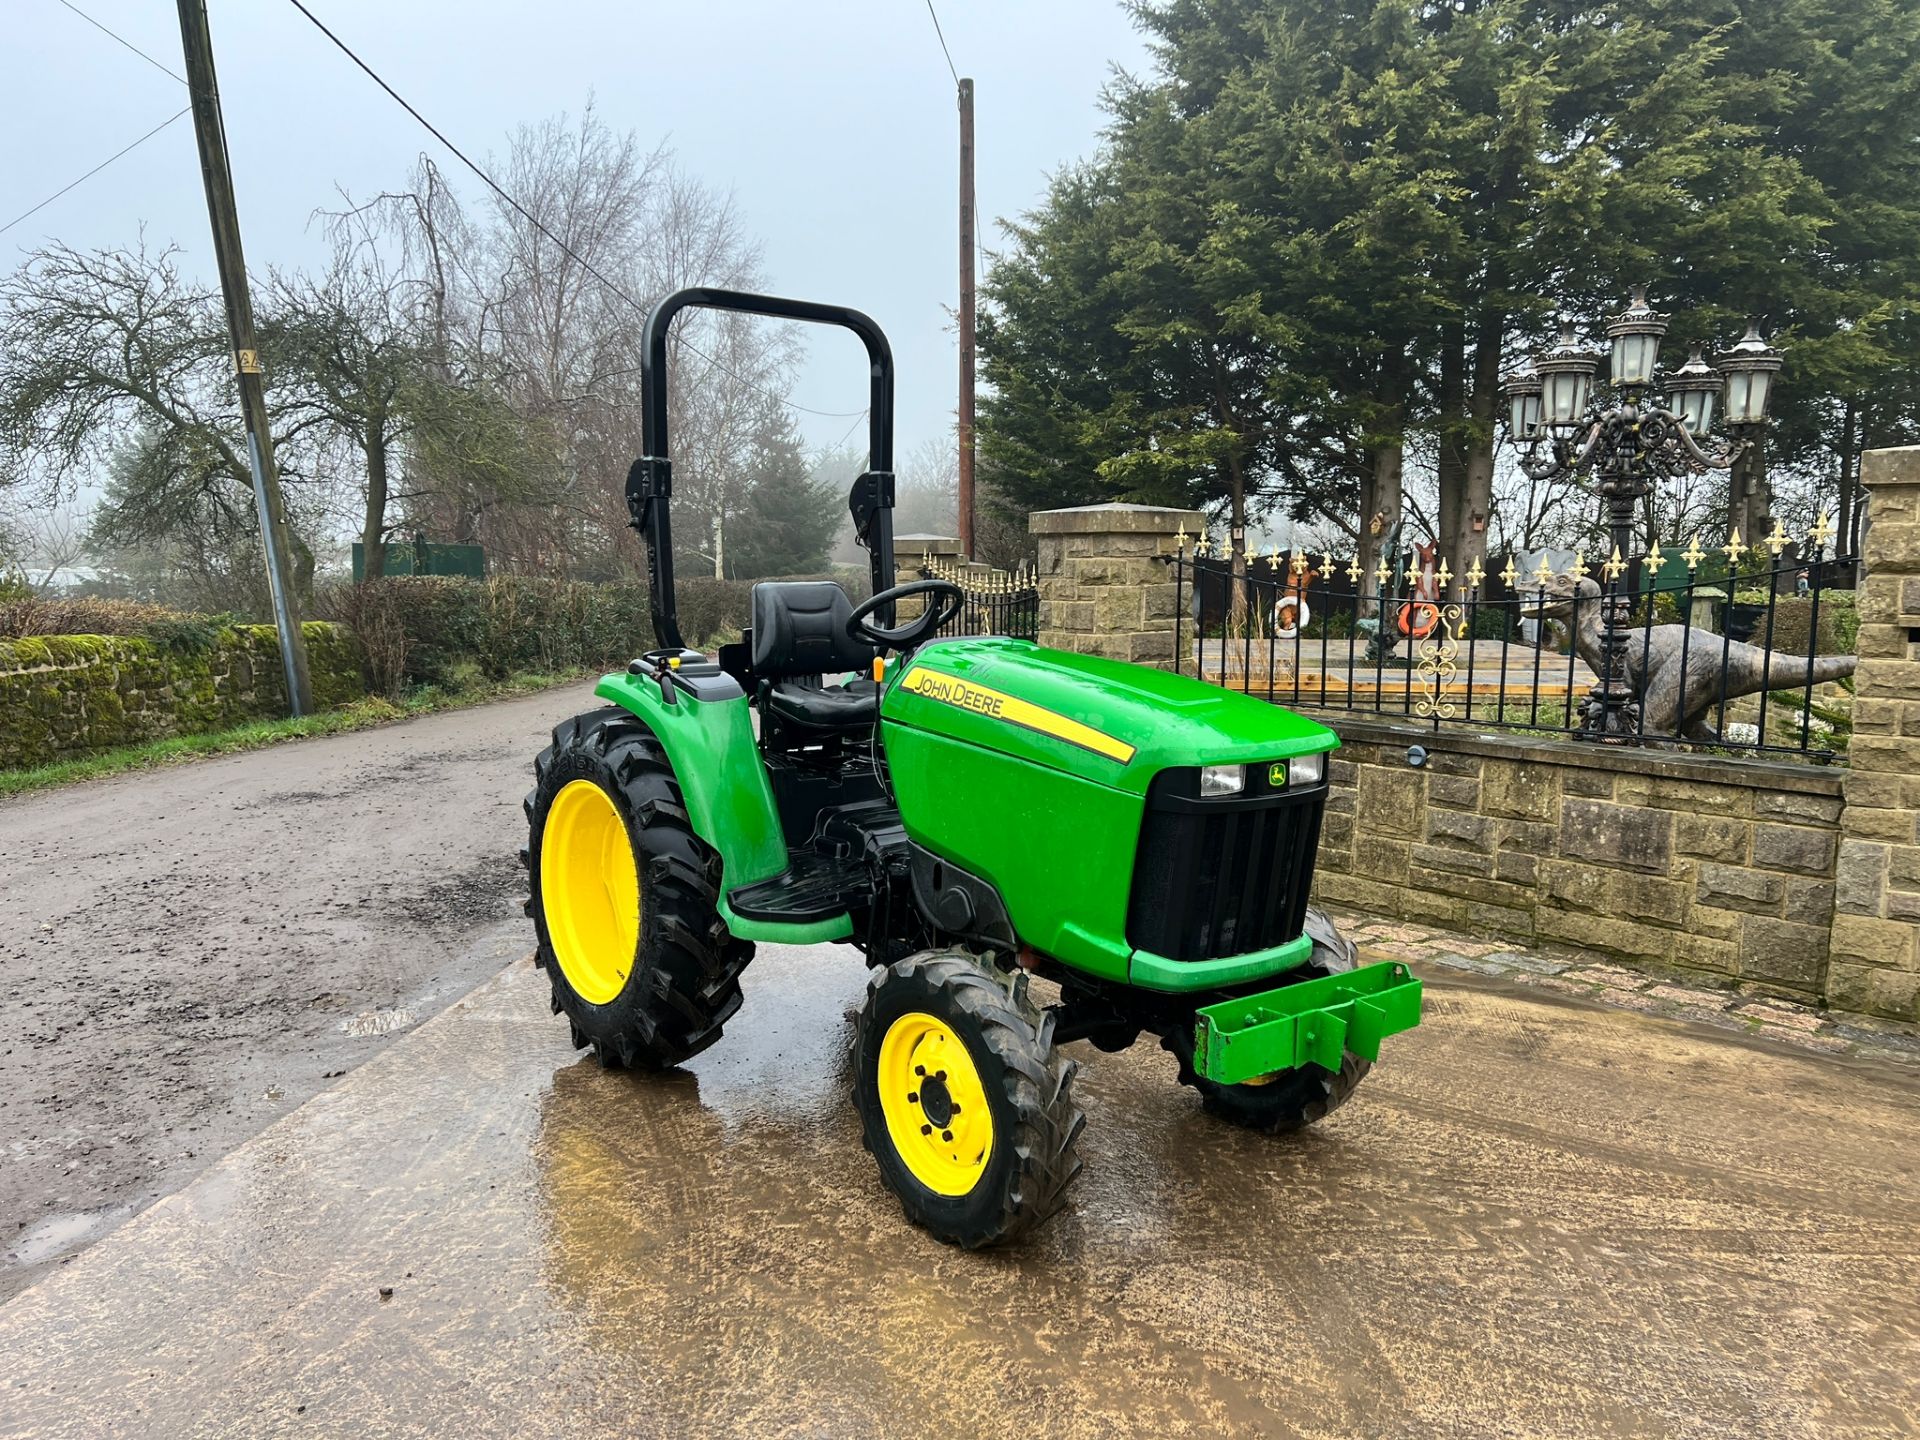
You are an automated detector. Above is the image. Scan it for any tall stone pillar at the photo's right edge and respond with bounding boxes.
[1828,445,1920,1020]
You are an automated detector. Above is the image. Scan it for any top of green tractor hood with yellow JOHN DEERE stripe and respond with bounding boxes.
[881,637,1340,795]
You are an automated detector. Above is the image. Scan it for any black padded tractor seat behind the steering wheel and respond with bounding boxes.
[753,580,879,735]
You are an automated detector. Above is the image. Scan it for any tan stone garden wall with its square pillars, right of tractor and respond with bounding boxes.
[1031,485,1920,1021]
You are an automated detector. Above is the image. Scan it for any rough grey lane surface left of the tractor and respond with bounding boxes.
[0,685,591,1302]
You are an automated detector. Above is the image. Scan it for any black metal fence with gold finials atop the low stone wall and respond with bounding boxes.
[1169,526,1857,762]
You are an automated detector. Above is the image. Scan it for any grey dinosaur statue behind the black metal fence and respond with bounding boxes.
[1521,574,1857,743]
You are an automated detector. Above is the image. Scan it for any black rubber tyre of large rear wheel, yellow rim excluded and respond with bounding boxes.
[520,707,753,1069]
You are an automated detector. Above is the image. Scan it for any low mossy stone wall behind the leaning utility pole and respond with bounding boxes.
[0,622,367,770]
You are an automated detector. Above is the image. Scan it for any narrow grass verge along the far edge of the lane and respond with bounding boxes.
[0,672,597,797]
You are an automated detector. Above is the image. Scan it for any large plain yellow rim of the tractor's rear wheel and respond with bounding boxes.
[540,780,639,1004]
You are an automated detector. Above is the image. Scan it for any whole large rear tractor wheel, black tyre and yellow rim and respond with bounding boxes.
[520,708,753,1069]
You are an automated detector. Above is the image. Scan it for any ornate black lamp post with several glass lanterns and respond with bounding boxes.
[1505,288,1780,743]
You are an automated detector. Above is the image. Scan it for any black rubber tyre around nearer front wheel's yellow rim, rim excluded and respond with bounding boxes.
[852,950,1087,1250]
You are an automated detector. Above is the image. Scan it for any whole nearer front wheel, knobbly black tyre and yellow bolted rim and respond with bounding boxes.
[852,950,1085,1250]
